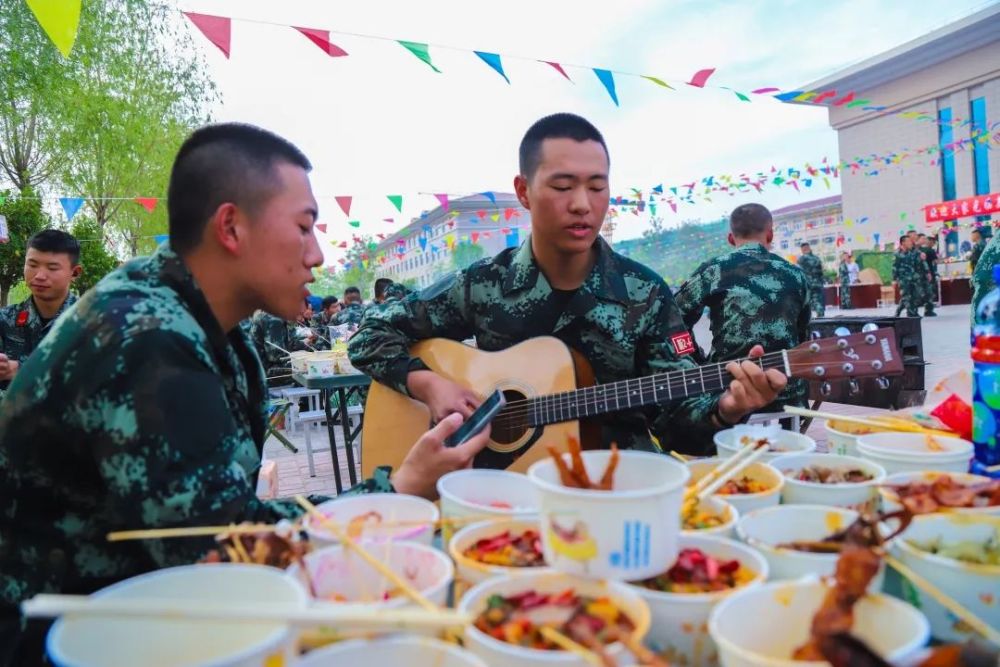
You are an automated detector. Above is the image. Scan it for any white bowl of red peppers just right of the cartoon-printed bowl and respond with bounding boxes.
[632,535,768,666]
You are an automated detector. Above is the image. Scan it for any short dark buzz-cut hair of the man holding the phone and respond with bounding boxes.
[167,123,312,255]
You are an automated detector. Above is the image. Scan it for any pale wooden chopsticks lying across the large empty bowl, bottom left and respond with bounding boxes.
[21,594,472,630]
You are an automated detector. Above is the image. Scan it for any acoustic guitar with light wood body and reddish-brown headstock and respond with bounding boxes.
[361,329,903,477]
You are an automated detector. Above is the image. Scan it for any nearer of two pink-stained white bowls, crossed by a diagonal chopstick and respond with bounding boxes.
[286,542,455,608]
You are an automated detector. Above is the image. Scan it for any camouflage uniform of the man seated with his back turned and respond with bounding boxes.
[674,243,810,412]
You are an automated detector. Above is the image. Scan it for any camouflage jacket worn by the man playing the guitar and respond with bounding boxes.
[348,239,719,454]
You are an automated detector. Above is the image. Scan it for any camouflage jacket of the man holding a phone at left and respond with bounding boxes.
[0,245,391,614]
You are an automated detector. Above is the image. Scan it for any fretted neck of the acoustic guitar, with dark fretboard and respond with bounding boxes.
[519,352,788,426]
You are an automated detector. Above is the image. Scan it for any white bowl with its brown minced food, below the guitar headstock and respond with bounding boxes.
[773,454,885,512]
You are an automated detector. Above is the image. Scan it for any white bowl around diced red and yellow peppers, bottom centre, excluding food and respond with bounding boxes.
[458,568,661,667]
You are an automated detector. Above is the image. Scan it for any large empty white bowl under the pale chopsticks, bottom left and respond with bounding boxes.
[46,563,308,667]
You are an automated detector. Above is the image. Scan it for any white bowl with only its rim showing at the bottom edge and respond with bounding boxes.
[293,637,487,667]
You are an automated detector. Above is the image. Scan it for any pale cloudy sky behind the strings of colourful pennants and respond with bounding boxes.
[178,0,989,263]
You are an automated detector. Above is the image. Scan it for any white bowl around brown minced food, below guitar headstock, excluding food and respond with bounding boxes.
[774,454,885,512]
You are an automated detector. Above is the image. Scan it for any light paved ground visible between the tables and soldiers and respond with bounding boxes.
[264,305,971,497]
